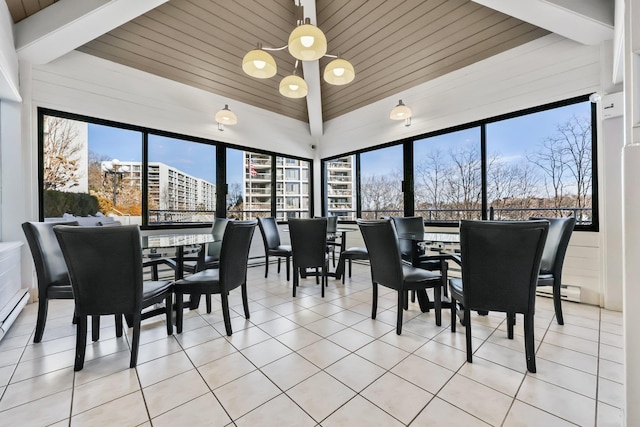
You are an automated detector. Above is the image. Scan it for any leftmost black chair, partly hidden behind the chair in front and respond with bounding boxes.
[22,221,78,343]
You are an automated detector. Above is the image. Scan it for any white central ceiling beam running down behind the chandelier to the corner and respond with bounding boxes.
[294,0,323,138]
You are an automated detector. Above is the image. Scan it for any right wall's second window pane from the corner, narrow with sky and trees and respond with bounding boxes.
[360,145,404,219]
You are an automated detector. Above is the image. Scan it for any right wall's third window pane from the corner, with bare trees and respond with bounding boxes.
[413,128,482,222]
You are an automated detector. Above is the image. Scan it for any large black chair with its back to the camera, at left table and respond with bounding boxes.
[53,225,173,371]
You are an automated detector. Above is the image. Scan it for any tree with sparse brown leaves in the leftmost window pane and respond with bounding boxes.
[43,116,83,190]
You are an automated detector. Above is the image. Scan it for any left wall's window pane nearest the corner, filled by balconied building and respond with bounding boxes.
[276,157,309,220]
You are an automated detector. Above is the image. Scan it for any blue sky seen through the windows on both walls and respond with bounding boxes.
[89,102,590,183]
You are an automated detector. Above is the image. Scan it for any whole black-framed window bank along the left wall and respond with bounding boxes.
[38,108,312,228]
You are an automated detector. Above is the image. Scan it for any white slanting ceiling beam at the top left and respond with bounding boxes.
[14,0,168,64]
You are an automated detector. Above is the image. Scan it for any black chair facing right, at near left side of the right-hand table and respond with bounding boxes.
[357,219,442,335]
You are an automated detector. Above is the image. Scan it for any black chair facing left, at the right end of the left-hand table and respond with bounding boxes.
[174,220,257,336]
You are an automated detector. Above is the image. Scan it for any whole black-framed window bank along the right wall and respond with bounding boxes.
[323,95,598,231]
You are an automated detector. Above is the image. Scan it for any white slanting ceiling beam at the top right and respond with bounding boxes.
[473,0,614,45]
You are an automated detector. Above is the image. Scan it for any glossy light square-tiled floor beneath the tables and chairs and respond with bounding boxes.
[0,265,623,427]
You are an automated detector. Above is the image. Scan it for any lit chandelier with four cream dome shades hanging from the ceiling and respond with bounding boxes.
[242,3,356,98]
